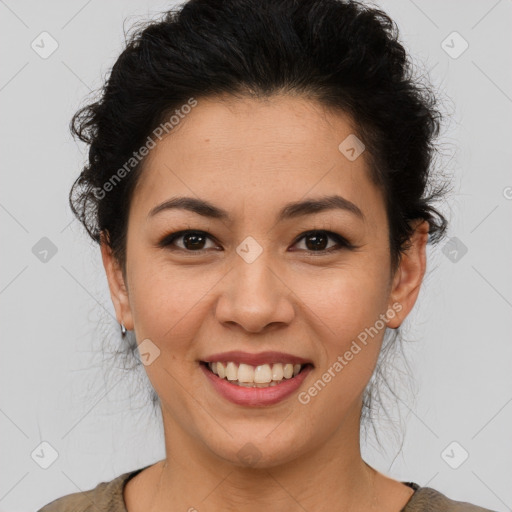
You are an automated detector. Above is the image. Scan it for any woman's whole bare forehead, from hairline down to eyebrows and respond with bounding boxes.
[132,96,380,223]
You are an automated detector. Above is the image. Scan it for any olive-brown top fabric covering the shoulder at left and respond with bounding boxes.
[37,466,147,512]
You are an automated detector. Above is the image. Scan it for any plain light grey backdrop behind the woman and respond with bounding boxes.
[0,0,512,512]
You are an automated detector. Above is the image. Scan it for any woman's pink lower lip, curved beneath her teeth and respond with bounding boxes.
[200,364,313,406]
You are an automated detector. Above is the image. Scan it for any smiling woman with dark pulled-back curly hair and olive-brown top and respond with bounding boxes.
[41,0,494,512]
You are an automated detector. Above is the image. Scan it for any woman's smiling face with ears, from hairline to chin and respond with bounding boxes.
[102,96,426,466]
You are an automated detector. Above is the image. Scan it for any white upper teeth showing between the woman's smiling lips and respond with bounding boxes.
[200,361,313,388]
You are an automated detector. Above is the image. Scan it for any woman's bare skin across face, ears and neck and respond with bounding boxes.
[101,95,428,512]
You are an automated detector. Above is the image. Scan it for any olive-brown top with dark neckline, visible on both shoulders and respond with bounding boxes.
[37,466,495,512]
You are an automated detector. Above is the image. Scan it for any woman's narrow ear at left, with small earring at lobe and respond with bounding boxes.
[100,231,133,331]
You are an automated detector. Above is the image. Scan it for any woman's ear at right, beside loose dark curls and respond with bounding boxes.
[388,220,429,329]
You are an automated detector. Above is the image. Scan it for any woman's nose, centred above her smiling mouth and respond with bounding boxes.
[215,246,295,333]
